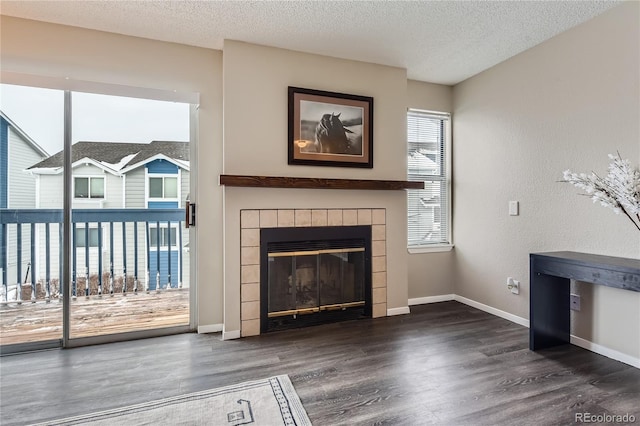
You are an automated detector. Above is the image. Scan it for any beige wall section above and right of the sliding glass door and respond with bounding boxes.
[0,16,222,324]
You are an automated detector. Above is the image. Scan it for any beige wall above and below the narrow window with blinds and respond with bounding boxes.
[407,80,456,299]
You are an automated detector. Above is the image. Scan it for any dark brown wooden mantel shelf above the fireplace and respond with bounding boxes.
[220,175,424,191]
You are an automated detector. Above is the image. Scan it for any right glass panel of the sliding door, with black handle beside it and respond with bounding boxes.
[69,92,191,338]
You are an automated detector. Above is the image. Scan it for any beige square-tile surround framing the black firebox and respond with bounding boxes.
[240,208,387,337]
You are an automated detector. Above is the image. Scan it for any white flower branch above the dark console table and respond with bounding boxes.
[563,153,640,231]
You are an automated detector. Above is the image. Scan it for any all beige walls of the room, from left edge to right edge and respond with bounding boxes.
[1,3,640,358]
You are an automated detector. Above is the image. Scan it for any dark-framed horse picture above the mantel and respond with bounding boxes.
[289,87,373,169]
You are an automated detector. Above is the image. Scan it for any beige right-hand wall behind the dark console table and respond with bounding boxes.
[453,2,640,359]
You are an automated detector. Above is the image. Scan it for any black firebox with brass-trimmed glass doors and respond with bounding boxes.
[260,226,371,333]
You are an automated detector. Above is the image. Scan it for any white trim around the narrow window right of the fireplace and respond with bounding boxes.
[405,108,455,254]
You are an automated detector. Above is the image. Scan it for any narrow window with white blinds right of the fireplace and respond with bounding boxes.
[407,109,451,248]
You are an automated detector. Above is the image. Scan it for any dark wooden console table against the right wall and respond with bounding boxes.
[529,251,640,351]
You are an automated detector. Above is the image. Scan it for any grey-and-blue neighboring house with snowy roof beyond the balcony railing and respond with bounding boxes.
[28,141,189,289]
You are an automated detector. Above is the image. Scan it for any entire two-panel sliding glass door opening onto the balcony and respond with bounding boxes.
[0,80,196,352]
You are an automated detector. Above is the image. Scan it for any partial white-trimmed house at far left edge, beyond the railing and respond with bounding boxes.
[0,111,49,292]
